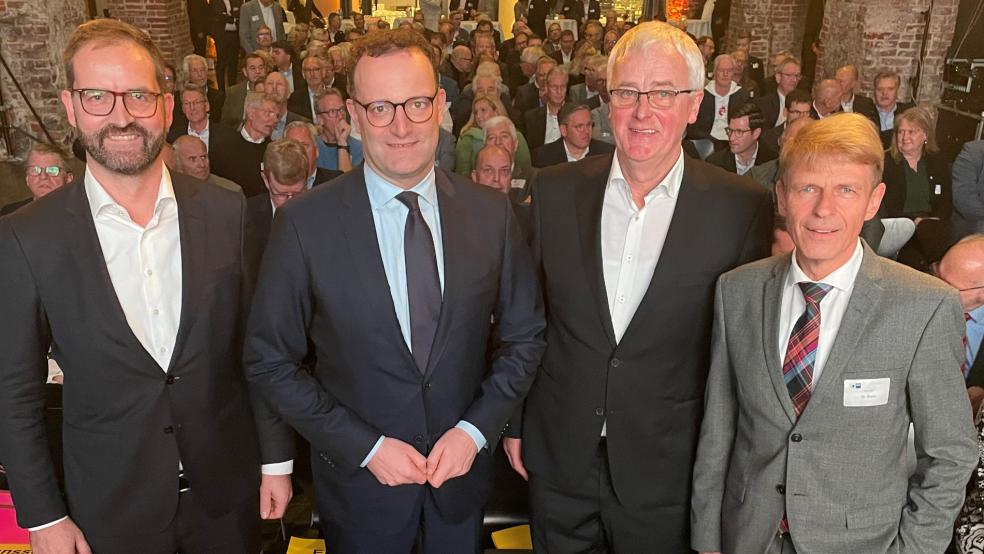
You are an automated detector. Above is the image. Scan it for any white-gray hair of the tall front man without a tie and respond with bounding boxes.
[608,21,704,90]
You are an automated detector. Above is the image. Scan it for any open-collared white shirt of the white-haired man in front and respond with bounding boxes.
[601,150,683,437]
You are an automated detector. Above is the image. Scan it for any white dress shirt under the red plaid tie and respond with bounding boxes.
[776,240,864,382]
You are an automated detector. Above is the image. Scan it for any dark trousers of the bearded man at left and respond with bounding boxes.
[83,487,260,554]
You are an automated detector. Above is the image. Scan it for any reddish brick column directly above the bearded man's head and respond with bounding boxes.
[106,0,194,65]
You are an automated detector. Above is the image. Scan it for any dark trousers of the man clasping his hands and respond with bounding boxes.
[322,485,482,554]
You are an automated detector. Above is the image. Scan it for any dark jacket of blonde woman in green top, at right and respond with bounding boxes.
[880,153,953,220]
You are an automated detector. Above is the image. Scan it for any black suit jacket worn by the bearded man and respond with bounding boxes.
[0,173,293,536]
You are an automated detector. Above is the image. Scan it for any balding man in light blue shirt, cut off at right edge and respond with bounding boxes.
[938,234,984,414]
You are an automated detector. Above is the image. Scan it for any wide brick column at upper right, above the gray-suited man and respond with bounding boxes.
[817,0,959,102]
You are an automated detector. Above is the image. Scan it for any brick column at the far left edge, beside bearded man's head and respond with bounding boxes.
[0,0,86,160]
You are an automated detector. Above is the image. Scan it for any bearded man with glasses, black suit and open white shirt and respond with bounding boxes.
[0,19,293,553]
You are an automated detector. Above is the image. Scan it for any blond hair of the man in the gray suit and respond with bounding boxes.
[779,113,885,187]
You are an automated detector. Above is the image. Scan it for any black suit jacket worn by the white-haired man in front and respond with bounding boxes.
[507,156,772,552]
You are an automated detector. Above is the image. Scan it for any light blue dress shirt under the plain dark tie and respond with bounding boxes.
[362,164,486,467]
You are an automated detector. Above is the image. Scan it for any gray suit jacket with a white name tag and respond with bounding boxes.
[691,246,977,553]
